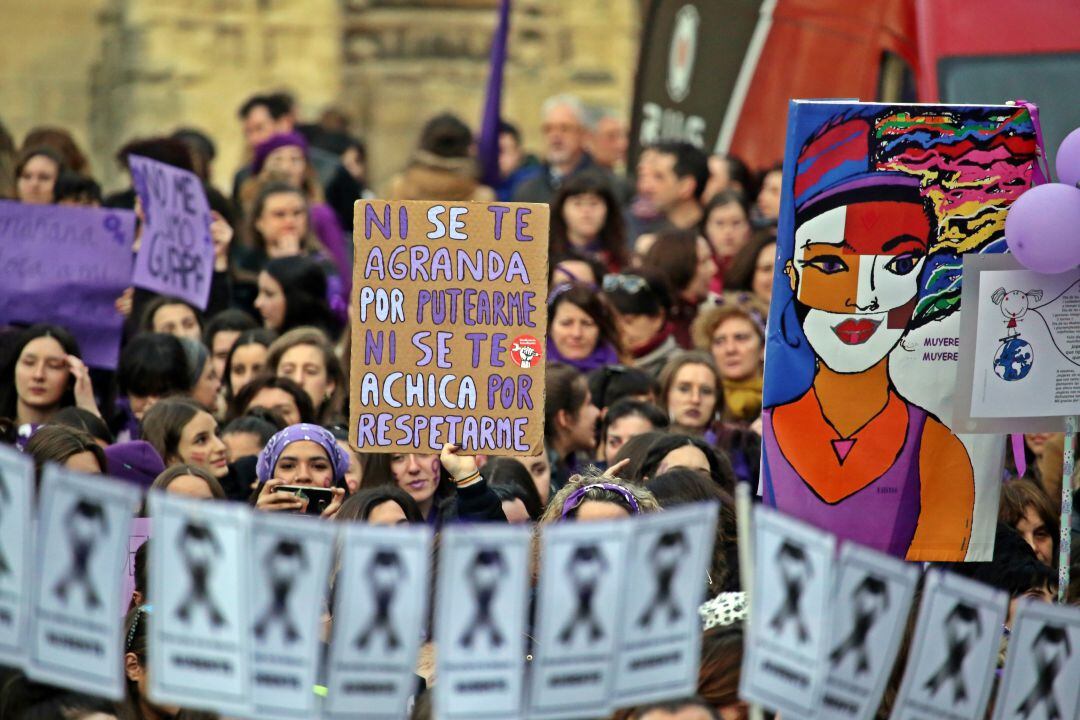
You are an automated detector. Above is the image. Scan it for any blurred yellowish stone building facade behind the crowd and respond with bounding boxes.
[0,0,639,189]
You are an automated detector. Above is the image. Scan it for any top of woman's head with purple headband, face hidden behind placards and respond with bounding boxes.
[540,475,660,525]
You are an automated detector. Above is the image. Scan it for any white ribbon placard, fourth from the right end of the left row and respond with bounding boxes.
[324,524,432,720]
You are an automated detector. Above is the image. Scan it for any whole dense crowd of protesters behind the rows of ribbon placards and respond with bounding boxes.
[0,88,1077,720]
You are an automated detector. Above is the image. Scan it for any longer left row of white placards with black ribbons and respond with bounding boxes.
[0,449,717,719]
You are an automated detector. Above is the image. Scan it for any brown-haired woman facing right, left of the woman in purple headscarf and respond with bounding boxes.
[143,397,229,481]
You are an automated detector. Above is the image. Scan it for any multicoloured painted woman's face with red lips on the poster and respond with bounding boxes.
[786,202,931,372]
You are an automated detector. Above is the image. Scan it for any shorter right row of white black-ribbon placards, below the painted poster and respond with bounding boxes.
[740,506,1080,720]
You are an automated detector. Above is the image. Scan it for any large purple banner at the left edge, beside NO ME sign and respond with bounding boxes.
[0,200,135,370]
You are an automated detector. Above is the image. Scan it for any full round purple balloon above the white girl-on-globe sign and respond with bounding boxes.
[1005,182,1080,274]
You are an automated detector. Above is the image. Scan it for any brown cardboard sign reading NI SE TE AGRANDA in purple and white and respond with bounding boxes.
[350,201,548,456]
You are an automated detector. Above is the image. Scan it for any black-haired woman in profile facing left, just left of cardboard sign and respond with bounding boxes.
[255,256,341,340]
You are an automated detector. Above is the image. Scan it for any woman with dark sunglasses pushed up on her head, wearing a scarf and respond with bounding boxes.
[604,268,679,377]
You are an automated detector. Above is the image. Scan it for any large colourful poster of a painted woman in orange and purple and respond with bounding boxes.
[761,100,1036,560]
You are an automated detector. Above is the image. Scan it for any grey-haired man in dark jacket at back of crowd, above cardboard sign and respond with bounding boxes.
[514,95,596,203]
